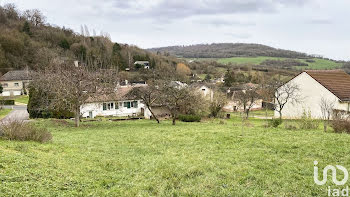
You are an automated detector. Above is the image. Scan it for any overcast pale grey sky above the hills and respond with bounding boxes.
[0,0,350,60]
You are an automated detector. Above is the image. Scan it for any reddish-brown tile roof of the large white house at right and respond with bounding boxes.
[305,70,350,101]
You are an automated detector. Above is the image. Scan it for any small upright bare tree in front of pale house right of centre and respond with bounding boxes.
[234,87,260,119]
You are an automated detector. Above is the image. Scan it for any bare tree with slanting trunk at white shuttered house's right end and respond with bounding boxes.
[130,84,160,124]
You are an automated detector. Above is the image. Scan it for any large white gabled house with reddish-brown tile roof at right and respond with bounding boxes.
[275,70,350,119]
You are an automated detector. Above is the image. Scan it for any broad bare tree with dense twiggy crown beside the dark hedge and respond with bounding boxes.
[32,64,117,127]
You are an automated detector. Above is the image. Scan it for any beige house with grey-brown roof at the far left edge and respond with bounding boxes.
[0,70,32,96]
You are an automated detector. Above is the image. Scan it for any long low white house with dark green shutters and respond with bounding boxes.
[80,85,150,118]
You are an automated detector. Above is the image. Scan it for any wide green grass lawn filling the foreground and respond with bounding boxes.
[0,118,350,196]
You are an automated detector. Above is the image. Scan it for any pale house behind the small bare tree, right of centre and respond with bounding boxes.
[223,83,263,112]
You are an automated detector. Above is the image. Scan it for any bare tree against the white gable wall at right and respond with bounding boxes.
[270,81,302,120]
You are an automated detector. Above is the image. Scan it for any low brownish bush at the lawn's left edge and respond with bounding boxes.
[0,121,52,143]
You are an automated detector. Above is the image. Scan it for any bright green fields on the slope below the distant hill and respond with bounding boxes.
[217,57,341,69]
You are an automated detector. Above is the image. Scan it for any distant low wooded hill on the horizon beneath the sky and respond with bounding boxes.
[148,43,309,58]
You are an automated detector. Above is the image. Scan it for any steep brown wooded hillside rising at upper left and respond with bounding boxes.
[0,4,176,73]
